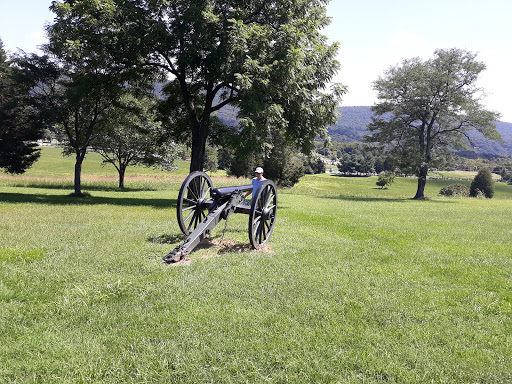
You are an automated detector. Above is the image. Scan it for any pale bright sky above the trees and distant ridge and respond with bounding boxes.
[0,0,512,122]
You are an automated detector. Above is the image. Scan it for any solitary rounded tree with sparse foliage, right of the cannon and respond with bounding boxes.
[366,48,500,199]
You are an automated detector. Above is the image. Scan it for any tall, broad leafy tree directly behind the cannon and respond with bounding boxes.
[51,0,344,171]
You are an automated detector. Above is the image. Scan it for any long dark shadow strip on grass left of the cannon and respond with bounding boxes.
[0,192,177,208]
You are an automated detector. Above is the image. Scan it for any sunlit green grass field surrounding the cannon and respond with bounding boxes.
[0,148,512,383]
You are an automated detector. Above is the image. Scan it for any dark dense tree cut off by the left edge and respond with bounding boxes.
[0,39,42,173]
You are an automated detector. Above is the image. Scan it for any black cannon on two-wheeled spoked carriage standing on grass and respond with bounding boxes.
[163,171,277,264]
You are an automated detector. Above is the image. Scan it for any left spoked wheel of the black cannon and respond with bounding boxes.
[177,171,213,236]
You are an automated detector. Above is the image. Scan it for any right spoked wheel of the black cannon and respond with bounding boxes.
[249,180,277,249]
